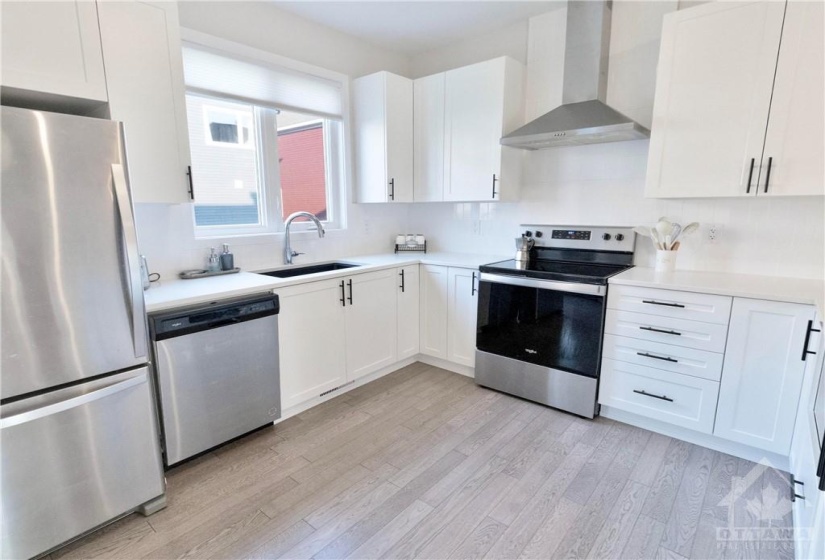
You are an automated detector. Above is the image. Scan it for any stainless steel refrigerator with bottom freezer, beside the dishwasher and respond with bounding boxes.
[0,107,165,558]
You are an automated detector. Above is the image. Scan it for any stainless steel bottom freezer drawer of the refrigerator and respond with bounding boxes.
[0,367,165,558]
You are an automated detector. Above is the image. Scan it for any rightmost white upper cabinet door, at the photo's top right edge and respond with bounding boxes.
[759,0,825,196]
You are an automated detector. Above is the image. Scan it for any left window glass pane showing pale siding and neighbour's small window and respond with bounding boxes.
[186,95,261,227]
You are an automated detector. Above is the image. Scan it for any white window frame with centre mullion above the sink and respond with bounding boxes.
[181,28,352,240]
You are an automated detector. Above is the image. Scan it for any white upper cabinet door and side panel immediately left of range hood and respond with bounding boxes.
[444,57,524,201]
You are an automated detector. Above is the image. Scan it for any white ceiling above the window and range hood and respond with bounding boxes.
[274,0,563,55]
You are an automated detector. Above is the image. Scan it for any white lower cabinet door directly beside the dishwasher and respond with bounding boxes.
[278,280,347,411]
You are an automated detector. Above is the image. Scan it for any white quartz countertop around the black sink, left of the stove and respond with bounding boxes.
[144,253,509,313]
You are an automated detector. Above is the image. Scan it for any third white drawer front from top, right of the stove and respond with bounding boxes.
[602,334,724,381]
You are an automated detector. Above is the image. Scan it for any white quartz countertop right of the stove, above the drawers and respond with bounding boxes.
[610,267,825,317]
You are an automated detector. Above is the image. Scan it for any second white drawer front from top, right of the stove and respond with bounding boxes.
[604,309,728,353]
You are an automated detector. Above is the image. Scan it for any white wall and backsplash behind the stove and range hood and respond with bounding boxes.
[408,0,825,278]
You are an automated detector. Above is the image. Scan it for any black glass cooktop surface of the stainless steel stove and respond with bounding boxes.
[479,259,631,284]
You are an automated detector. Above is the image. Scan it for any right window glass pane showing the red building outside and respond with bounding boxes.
[278,111,330,221]
